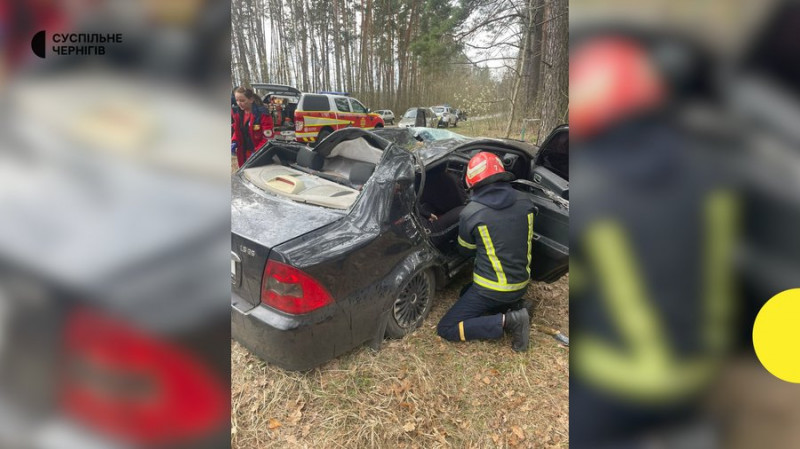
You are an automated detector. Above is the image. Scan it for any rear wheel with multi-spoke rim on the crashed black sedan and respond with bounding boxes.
[386,270,436,338]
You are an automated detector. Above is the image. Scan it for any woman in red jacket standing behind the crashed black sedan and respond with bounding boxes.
[231,87,273,167]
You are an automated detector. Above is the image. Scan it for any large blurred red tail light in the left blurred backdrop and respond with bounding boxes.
[60,309,230,445]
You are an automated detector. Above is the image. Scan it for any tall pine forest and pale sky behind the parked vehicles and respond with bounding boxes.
[231,0,569,141]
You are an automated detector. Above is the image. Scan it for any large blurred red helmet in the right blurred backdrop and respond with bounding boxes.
[569,36,666,138]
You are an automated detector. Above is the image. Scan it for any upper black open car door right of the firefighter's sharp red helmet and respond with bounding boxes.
[531,125,569,199]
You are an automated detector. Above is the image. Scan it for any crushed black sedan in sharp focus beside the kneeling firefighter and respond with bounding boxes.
[231,128,569,370]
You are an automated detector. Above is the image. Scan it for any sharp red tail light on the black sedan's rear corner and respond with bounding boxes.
[261,260,333,315]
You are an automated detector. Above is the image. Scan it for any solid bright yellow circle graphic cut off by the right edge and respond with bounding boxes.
[753,288,800,383]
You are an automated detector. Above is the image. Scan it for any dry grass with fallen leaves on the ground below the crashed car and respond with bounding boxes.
[231,274,569,448]
